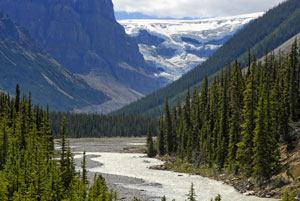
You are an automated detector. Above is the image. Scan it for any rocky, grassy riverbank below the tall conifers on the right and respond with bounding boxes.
[151,130,300,200]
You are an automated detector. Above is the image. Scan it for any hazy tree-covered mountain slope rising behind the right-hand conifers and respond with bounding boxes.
[117,0,300,115]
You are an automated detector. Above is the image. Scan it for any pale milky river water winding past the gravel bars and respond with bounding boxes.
[75,152,275,201]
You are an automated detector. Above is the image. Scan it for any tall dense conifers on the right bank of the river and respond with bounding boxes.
[148,41,300,182]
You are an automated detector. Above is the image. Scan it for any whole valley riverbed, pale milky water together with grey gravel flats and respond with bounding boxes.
[62,138,278,201]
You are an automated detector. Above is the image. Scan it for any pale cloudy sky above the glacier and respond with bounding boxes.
[113,0,283,18]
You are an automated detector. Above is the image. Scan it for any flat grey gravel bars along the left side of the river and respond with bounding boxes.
[66,138,153,201]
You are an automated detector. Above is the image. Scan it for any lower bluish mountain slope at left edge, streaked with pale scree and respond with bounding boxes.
[0,11,109,111]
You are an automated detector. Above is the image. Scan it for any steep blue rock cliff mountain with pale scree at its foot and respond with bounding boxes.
[0,0,163,112]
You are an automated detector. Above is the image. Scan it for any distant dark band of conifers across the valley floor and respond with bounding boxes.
[50,112,158,138]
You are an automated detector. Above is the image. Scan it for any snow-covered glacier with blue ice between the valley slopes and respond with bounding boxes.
[119,13,263,82]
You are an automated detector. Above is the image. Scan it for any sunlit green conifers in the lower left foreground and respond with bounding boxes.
[0,86,116,201]
